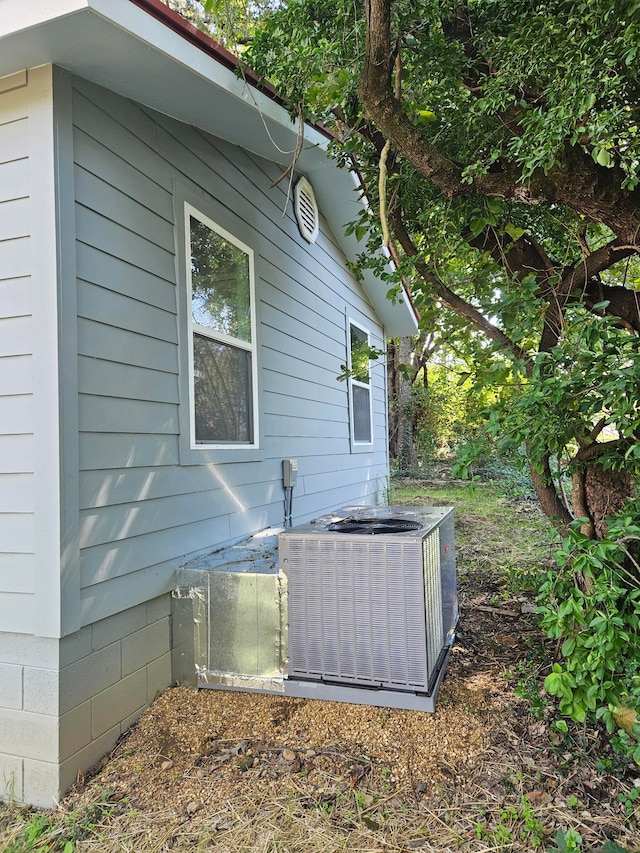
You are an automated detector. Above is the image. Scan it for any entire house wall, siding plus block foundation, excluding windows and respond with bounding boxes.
[0,66,388,806]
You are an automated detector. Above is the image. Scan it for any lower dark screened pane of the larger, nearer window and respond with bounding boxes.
[193,335,253,444]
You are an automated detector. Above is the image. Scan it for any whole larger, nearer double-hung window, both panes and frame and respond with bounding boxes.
[185,205,257,448]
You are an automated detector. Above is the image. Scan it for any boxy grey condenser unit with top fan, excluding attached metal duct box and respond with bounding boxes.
[278,506,458,711]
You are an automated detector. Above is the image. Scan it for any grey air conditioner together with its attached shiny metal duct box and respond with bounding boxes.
[172,506,458,712]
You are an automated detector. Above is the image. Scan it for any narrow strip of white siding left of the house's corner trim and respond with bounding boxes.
[0,75,35,612]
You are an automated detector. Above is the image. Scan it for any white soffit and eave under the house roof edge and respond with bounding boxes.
[0,0,417,335]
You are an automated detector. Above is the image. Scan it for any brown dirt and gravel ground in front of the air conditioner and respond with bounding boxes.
[60,500,640,853]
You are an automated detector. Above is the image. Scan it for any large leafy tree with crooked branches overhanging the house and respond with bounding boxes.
[242,0,640,536]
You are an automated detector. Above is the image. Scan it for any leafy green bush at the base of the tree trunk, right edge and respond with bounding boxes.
[537,502,640,732]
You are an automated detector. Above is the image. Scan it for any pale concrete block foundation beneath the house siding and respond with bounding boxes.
[0,595,171,808]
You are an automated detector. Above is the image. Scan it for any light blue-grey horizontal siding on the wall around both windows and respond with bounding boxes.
[73,80,386,622]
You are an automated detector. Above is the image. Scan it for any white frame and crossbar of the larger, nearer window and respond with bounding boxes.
[184,202,260,453]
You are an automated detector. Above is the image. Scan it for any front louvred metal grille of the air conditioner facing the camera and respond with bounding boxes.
[288,532,432,690]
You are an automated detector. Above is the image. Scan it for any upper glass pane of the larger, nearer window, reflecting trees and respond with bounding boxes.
[190,216,251,342]
